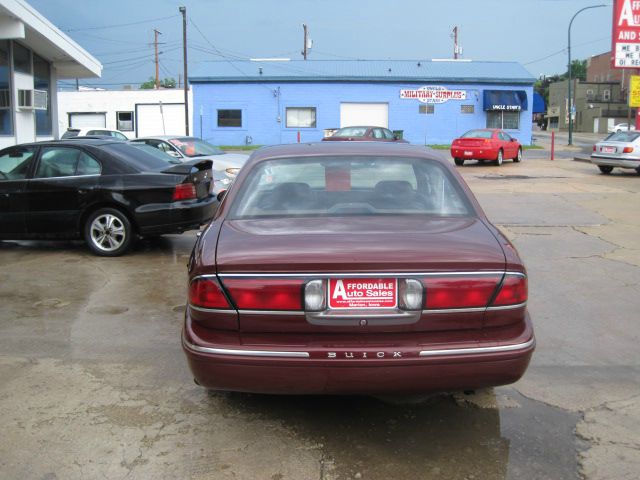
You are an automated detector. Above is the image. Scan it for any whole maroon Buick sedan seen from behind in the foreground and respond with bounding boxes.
[182,142,535,394]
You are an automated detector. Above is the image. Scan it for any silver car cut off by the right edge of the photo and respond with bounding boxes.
[591,130,640,175]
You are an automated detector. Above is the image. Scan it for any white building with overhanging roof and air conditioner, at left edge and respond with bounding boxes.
[0,0,102,148]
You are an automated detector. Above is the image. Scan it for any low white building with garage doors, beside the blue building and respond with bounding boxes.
[58,88,191,138]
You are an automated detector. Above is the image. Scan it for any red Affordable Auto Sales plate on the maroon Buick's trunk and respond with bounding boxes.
[328,278,398,309]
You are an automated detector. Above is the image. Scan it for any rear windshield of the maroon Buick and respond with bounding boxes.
[229,156,473,219]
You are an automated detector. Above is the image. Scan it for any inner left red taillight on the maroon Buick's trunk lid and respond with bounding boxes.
[224,278,304,310]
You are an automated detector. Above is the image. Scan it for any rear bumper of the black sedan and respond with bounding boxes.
[135,195,218,235]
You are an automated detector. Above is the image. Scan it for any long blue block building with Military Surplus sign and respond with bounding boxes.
[189,59,535,145]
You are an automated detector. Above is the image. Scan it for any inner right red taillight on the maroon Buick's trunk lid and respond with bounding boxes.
[423,275,500,310]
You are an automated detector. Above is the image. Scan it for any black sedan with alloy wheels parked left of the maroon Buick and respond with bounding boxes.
[0,139,218,256]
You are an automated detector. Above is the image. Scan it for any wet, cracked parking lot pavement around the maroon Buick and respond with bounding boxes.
[0,150,640,480]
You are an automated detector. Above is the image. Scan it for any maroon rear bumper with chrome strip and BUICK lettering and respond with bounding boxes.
[182,315,535,394]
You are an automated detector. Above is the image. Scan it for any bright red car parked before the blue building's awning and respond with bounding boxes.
[451,128,522,167]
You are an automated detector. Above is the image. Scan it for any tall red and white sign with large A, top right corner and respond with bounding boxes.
[611,0,640,68]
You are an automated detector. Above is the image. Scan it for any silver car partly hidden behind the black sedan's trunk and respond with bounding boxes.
[132,135,249,182]
